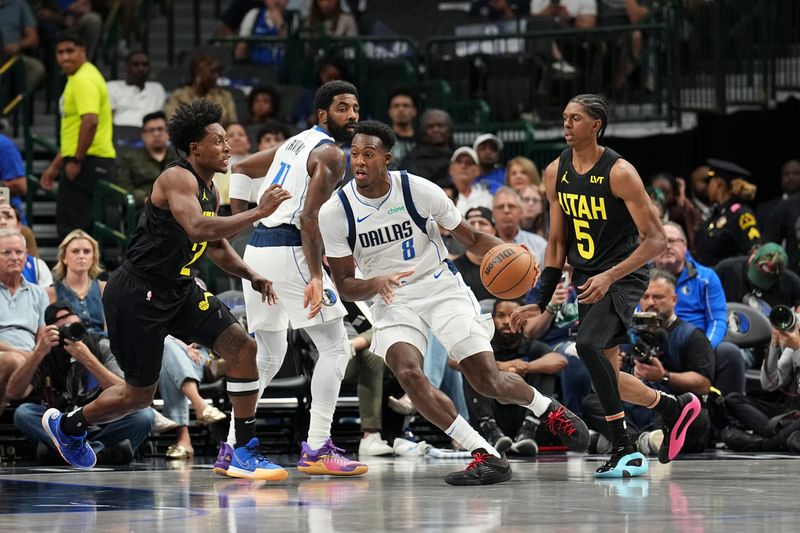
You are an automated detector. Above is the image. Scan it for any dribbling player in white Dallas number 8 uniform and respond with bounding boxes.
[319,121,589,485]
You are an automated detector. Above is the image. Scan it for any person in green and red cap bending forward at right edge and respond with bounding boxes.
[714,242,800,314]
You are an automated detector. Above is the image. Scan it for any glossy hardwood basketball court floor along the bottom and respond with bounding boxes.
[0,453,800,533]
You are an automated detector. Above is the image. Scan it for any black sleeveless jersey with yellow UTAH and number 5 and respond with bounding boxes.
[556,148,639,273]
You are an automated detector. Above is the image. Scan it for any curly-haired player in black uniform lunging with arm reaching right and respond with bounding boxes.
[42,100,290,479]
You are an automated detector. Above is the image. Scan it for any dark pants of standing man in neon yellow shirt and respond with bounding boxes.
[56,156,114,240]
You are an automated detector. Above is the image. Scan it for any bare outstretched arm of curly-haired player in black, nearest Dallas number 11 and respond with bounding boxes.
[156,167,291,242]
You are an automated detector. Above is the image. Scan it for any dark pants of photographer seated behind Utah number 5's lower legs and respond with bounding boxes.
[583,393,711,453]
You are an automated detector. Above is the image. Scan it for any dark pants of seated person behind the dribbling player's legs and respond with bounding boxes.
[463,374,556,437]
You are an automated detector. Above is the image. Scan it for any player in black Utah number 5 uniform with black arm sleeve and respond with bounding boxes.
[511,94,700,477]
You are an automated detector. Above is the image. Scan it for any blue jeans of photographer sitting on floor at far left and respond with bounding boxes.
[14,403,154,453]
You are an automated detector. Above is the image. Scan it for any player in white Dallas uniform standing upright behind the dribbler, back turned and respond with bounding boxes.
[214,81,367,476]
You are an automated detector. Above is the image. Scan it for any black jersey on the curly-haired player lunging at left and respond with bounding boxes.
[125,160,217,281]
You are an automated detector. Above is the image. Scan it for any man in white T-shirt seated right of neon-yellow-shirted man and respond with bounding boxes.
[106,51,167,128]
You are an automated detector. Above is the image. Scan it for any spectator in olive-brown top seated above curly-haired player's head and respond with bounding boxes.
[164,54,239,126]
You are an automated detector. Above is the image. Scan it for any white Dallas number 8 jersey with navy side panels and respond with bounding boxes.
[320,171,461,281]
